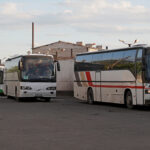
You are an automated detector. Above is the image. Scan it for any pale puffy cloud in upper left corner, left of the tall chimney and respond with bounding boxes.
[0,2,34,30]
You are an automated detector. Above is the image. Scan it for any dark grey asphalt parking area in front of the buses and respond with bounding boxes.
[0,96,150,150]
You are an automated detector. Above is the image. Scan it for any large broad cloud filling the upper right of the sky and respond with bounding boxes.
[52,0,150,33]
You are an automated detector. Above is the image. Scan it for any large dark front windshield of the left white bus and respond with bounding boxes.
[21,56,55,82]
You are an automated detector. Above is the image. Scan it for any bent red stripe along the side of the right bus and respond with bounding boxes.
[86,72,144,89]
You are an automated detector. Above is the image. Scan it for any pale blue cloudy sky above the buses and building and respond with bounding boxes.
[0,0,150,59]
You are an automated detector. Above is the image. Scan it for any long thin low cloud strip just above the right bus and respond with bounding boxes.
[74,23,150,36]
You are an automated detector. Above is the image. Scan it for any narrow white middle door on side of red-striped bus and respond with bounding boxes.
[94,71,101,101]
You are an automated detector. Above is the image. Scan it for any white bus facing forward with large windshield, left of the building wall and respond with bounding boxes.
[4,54,59,101]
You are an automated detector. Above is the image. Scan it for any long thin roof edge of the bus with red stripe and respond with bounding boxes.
[77,44,150,56]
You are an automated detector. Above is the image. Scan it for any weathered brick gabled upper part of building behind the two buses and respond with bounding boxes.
[32,41,97,59]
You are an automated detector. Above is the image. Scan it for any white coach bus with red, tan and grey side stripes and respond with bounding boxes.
[74,45,150,108]
